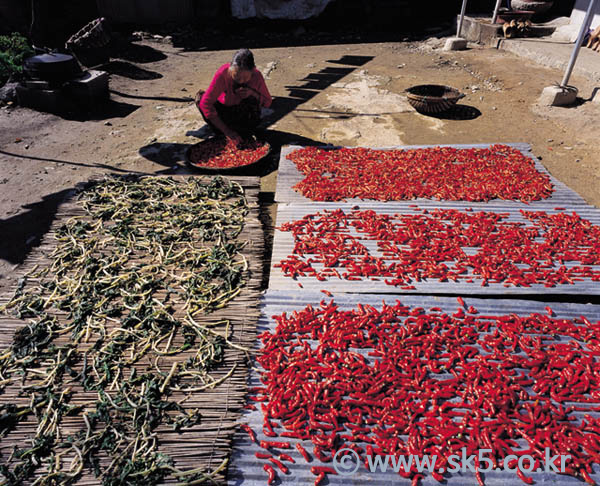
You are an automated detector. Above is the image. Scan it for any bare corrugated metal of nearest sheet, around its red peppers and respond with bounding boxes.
[228,291,600,486]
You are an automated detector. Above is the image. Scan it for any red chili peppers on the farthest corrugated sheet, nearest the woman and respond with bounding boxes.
[288,145,552,201]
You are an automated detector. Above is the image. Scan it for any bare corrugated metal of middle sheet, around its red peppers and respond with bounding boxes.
[269,201,600,295]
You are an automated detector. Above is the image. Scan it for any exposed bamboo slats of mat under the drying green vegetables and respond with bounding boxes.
[0,176,264,486]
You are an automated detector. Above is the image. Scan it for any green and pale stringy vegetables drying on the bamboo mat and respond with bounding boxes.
[0,177,248,486]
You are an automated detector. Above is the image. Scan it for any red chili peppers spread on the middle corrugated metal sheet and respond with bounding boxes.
[276,208,600,290]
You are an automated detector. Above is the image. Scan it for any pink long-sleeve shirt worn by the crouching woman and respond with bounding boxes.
[198,63,273,118]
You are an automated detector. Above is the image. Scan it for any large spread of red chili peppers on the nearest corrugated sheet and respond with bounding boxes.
[244,297,600,485]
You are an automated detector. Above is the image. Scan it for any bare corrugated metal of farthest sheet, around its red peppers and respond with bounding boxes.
[275,143,586,209]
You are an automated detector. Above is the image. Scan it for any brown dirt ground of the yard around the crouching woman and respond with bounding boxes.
[0,38,600,291]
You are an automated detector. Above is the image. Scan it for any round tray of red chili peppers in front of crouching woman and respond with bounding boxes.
[186,138,271,172]
